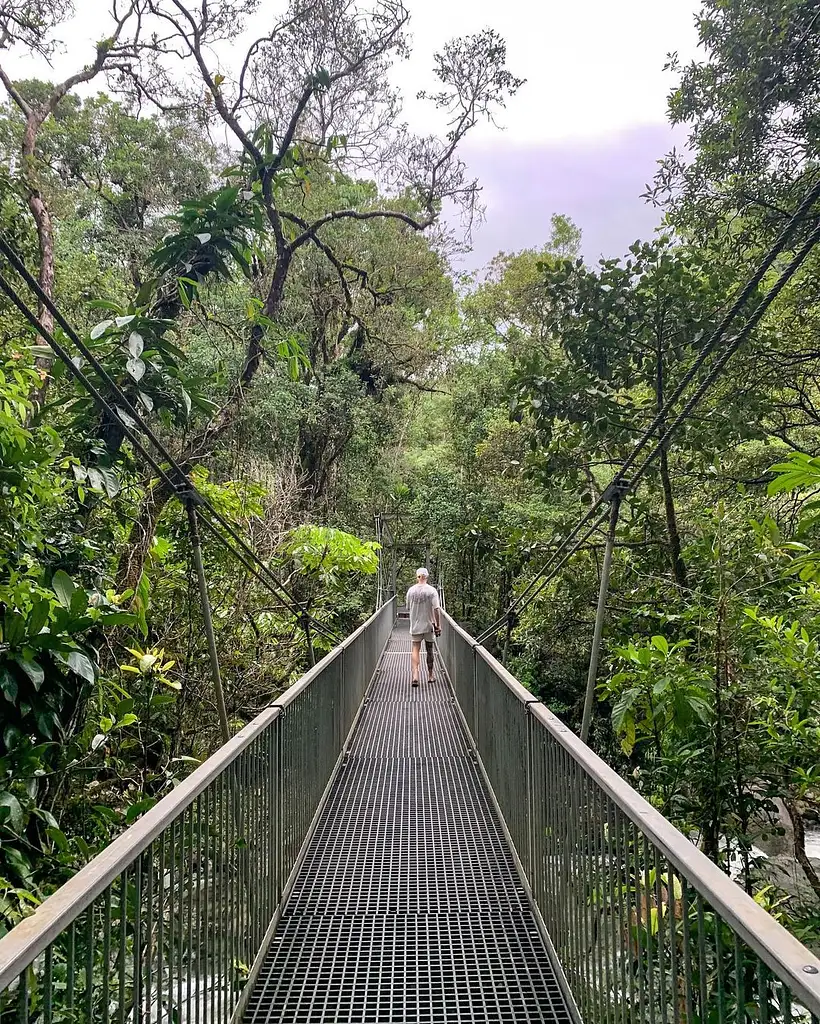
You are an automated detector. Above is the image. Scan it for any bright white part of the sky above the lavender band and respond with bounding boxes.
[4,0,699,145]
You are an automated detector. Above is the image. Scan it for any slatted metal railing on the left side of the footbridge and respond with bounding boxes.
[0,600,395,1024]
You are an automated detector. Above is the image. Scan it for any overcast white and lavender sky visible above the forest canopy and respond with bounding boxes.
[3,0,699,268]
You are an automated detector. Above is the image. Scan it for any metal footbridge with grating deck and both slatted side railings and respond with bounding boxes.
[0,596,820,1024]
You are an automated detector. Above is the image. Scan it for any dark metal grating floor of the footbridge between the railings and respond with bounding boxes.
[245,621,571,1024]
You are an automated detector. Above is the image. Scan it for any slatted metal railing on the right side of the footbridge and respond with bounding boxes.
[440,615,820,1024]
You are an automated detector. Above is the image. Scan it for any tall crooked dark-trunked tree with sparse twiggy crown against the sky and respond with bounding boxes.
[108,0,521,585]
